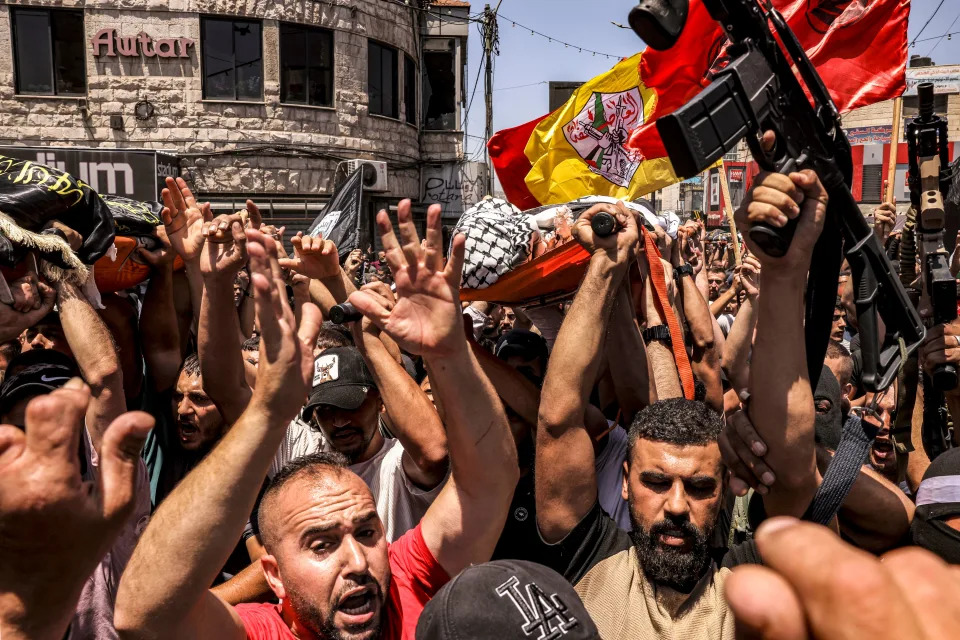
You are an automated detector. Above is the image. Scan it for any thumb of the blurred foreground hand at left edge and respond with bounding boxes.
[100,411,155,521]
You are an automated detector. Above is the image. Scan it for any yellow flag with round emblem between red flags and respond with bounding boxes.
[524,53,680,204]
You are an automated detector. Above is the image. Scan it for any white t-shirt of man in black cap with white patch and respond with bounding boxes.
[270,420,446,542]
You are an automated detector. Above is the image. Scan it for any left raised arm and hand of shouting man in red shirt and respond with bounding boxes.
[114,230,320,640]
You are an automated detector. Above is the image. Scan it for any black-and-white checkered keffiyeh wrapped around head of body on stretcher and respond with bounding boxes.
[454,198,534,289]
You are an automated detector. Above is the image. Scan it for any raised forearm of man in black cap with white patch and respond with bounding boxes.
[352,282,447,489]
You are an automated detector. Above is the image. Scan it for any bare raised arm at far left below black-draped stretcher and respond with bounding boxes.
[57,282,127,453]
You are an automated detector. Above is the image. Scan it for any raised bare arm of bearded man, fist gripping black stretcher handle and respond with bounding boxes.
[536,204,639,542]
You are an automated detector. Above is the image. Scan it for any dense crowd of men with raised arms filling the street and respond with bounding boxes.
[0,165,960,640]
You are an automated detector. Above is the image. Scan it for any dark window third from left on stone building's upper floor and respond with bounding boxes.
[280,23,333,107]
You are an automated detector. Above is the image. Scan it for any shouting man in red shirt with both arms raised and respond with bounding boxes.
[115,201,518,640]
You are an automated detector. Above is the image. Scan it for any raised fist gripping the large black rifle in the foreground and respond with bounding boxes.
[736,169,828,277]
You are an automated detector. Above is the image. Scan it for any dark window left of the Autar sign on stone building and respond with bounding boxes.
[11,9,87,96]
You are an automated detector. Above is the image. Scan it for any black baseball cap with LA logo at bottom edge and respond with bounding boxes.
[416,560,600,640]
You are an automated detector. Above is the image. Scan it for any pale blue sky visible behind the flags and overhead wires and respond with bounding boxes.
[467,0,960,159]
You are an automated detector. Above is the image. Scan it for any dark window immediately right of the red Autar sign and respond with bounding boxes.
[200,18,263,100]
